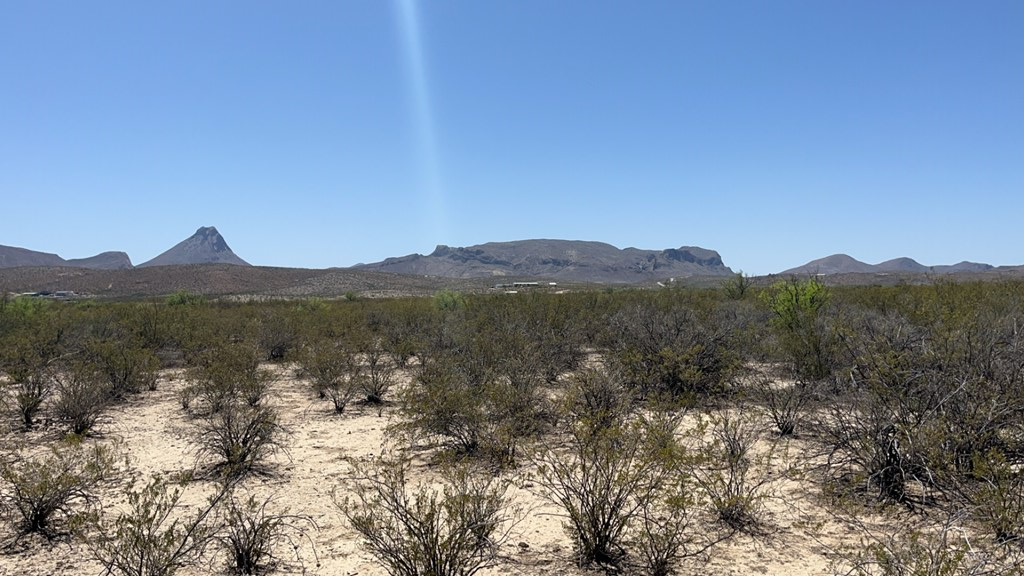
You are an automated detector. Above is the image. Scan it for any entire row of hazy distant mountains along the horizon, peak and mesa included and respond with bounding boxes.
[0,227,1024,284]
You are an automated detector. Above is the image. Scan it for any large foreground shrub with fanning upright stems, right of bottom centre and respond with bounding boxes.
[535,409,678,568]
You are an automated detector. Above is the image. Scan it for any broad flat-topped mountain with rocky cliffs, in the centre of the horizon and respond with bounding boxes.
[352,240,732,283]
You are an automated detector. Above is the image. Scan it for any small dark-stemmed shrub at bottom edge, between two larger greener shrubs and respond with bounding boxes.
[215,487,317,574]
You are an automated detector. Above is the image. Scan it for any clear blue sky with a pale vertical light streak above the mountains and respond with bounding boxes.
[0,0,1024,274]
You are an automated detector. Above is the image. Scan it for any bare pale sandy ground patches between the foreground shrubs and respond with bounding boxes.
[0,368,909,576]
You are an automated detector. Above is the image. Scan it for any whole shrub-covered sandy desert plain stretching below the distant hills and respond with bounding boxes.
[0,276,1024,576]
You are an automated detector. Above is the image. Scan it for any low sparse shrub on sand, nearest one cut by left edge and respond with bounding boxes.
[0,444,116,538]
